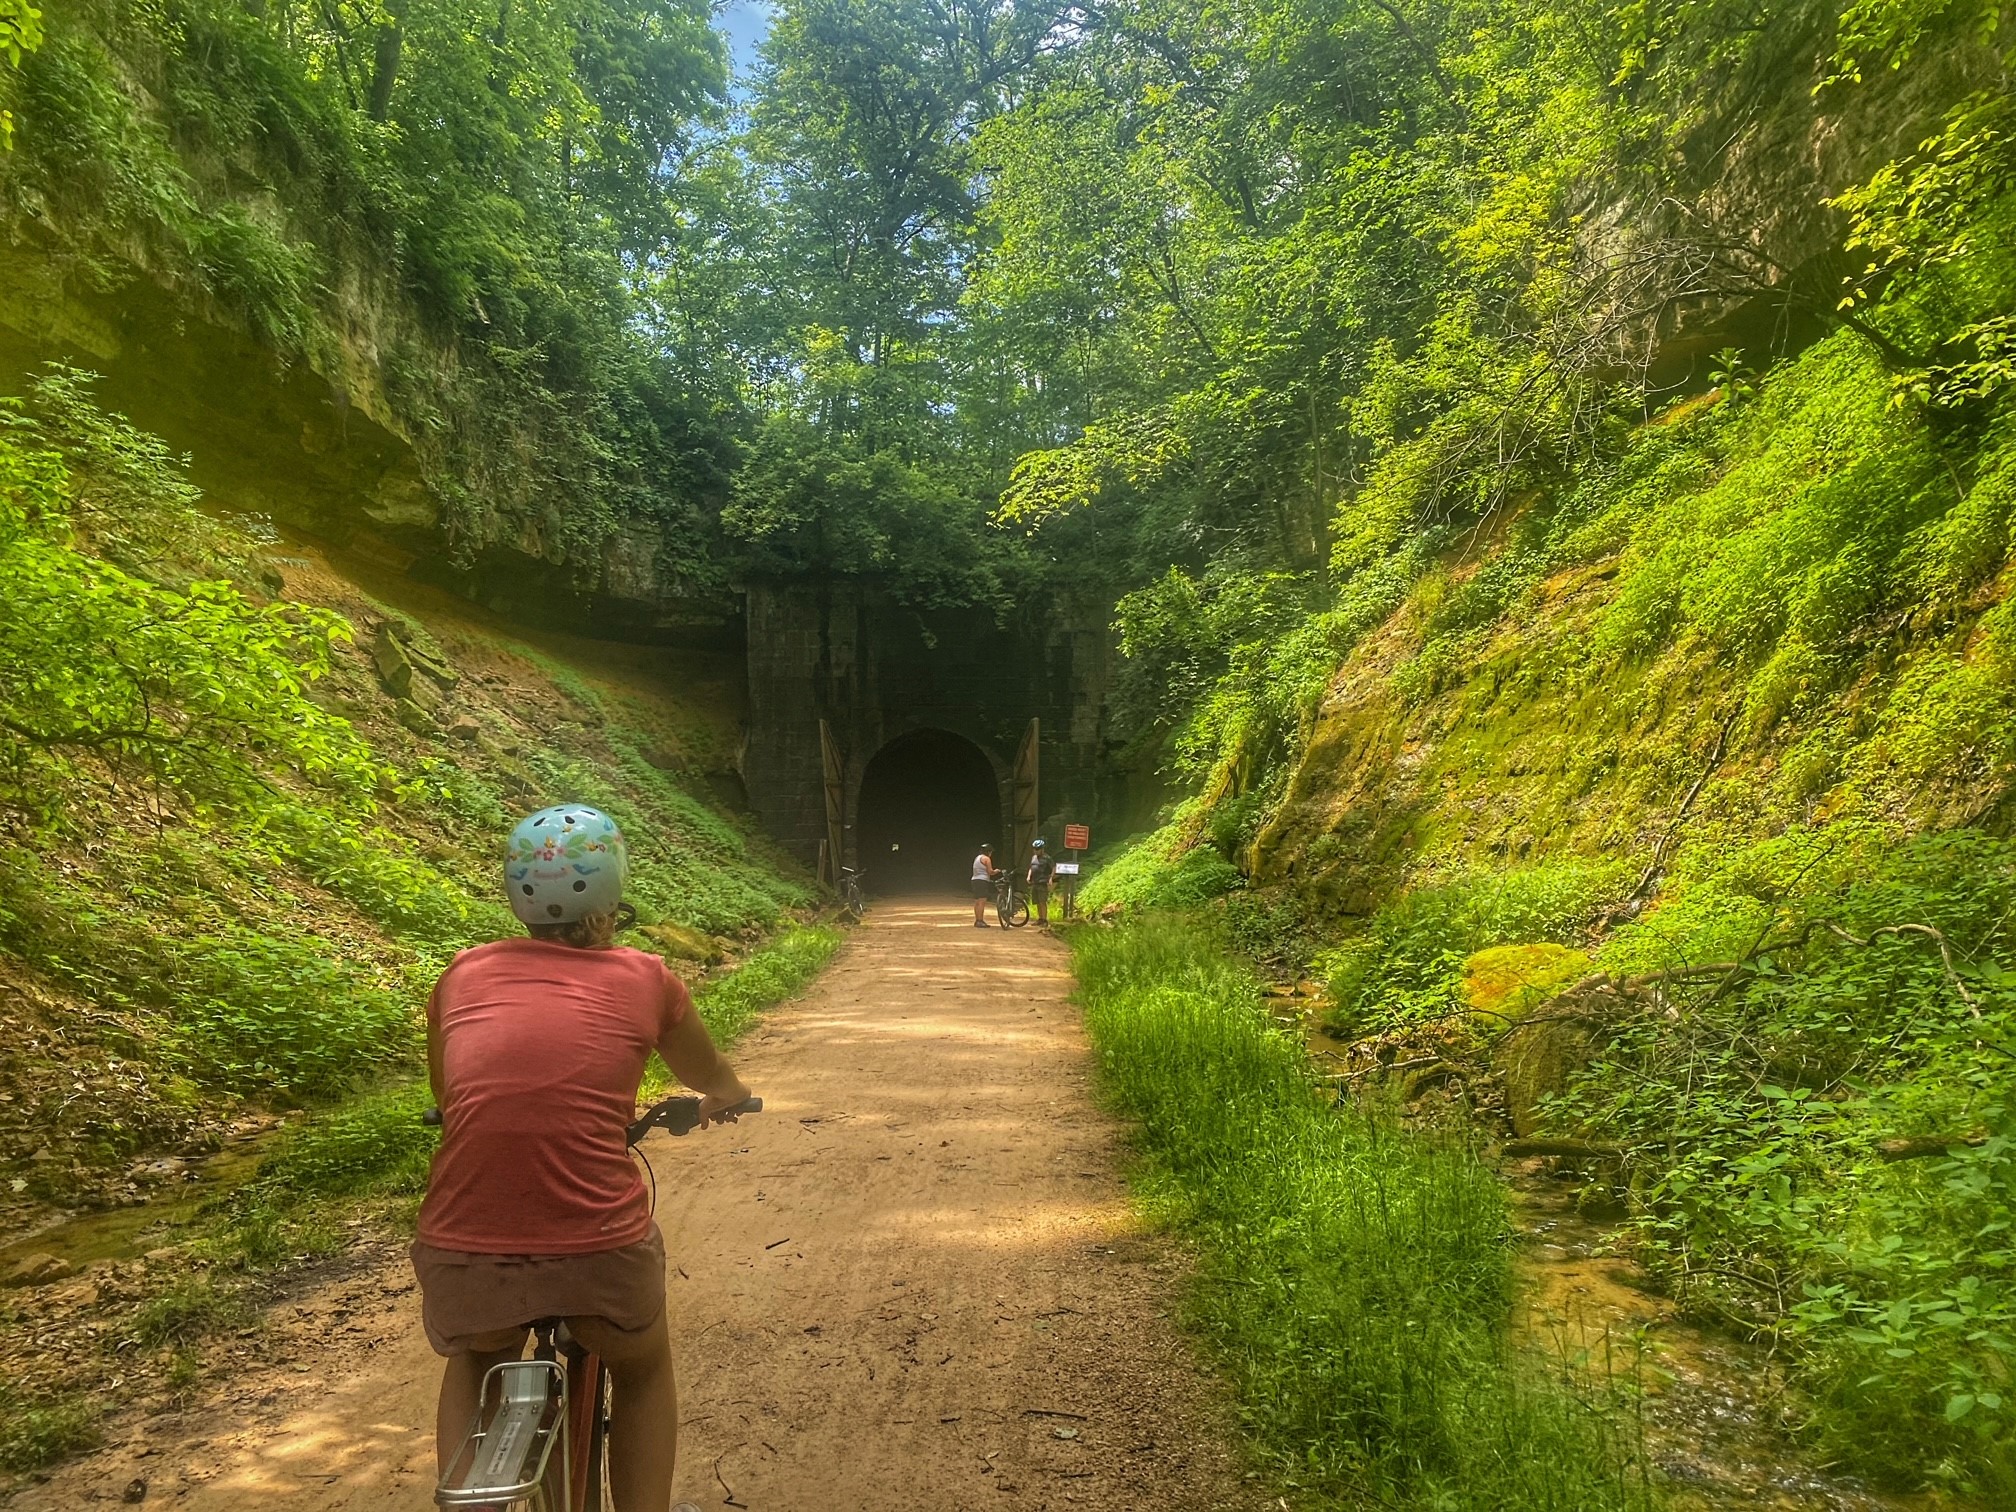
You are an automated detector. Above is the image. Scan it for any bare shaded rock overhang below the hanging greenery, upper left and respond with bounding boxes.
[0,224,736,643]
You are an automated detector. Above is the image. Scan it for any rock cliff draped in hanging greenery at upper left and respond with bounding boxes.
[0,0,734,639]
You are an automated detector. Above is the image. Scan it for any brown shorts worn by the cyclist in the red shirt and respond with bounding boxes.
[411,1224,665,1355]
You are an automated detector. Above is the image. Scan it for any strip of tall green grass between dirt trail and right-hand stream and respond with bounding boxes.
[1073,917,1651,1512]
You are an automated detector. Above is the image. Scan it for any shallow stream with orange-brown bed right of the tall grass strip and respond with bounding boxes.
[1268,984,1982,1512]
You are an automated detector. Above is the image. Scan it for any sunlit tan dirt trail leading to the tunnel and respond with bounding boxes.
[14,901,1272,1512]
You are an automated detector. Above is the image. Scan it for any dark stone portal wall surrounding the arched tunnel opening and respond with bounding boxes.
[742,581,1125,883]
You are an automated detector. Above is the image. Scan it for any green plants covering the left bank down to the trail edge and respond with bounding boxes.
[0,371,837,1470]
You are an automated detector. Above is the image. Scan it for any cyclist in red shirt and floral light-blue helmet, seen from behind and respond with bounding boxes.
[413,802,750,1512]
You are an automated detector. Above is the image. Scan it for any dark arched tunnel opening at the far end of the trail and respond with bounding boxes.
[855,730,1002,893]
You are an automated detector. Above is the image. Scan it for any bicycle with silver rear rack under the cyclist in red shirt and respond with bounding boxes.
[425,1095,762,1512]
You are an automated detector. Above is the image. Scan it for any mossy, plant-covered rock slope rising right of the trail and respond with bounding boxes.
[1246,333,2016,915]
